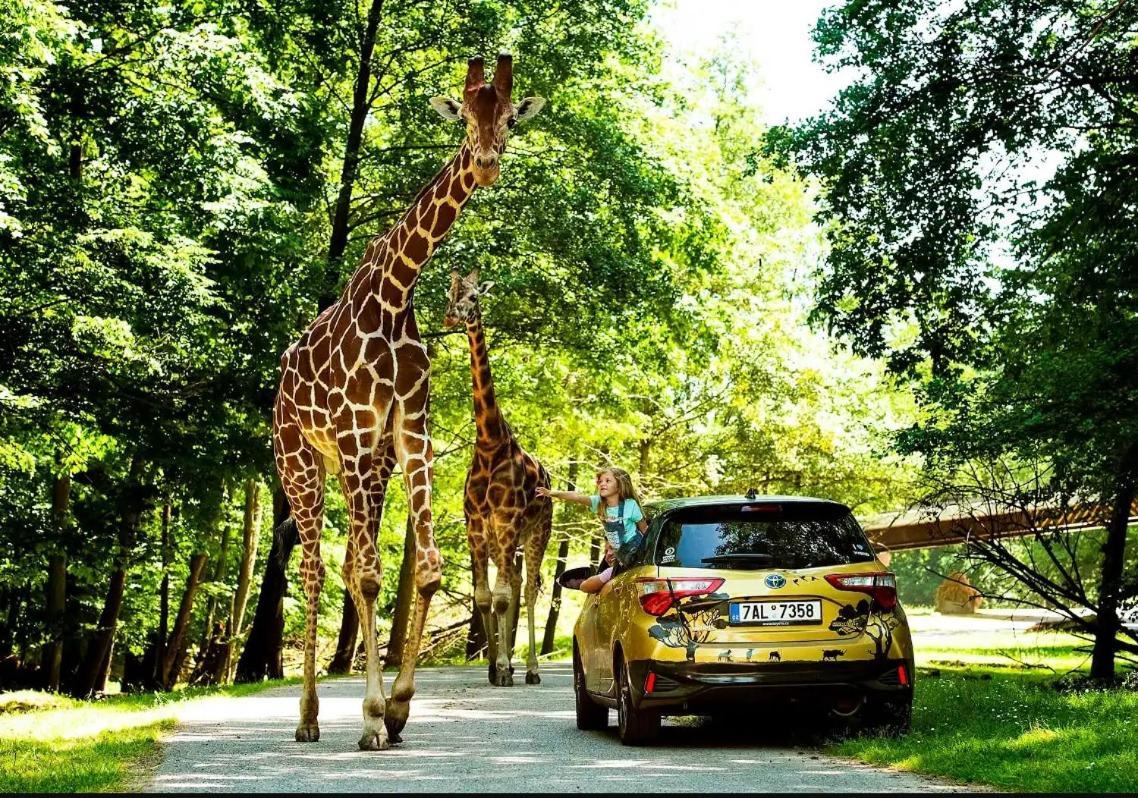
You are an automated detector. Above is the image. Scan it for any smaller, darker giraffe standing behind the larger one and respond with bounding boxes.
[443,269,553,686]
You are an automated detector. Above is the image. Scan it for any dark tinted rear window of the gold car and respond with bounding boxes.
[655,502,874,568]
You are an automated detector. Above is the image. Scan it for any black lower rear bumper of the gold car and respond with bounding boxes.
[628,659,913,714]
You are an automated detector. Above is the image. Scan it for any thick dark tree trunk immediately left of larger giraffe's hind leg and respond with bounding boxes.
[234,486,298,682]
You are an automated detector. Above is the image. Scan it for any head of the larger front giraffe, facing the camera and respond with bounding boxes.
[430,54,545,186]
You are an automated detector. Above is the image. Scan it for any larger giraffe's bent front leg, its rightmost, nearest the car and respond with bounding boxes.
[385,396,443,734]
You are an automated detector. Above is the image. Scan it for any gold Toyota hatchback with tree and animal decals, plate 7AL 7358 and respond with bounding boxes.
[572,494,914,744]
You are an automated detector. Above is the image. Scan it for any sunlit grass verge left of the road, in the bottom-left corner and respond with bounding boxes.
[0,680,297,792]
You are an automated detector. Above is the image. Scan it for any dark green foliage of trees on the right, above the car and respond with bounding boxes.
[770,0,1138,667]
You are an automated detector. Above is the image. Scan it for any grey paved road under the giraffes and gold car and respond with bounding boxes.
[150,664,969,793]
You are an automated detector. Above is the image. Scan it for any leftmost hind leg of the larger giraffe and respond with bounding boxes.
[274,427,324,742]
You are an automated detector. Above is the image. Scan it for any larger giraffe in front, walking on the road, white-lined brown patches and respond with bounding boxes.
[273,55,545,750]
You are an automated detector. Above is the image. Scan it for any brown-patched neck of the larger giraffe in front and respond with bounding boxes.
[365,141,476,311]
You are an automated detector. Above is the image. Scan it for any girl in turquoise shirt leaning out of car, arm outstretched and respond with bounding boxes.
[537,468,648,593]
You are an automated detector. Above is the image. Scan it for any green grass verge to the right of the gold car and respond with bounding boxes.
[832,633,1138,792]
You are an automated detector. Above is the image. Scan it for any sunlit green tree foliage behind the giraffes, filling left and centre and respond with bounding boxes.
[0,0,912,687]
